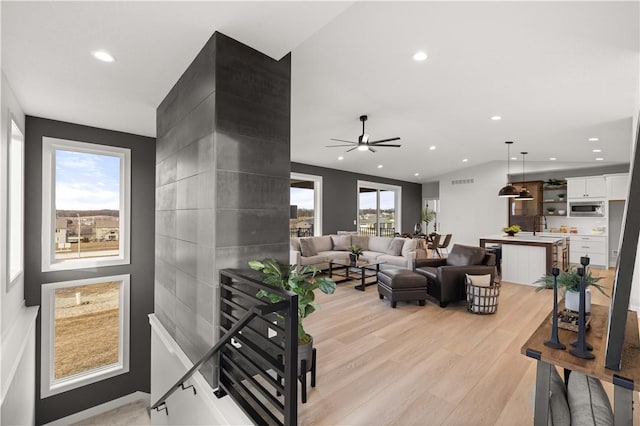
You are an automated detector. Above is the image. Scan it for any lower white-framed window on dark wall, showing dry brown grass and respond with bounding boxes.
[41,275,129,397]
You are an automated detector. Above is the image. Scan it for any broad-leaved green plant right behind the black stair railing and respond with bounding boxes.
[249,259,336,345]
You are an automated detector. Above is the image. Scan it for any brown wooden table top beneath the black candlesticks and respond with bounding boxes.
[520,303,640,391]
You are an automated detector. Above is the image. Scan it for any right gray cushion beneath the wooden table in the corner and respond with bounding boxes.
[567,371,613,426]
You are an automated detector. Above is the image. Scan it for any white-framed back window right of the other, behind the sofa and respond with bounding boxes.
[358,181,402,237]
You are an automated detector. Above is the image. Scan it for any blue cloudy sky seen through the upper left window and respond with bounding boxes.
[55,150,120,210]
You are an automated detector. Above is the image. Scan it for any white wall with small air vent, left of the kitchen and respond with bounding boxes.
[438,161,508,246]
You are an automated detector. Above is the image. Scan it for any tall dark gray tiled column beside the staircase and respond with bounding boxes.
[155,33,290,384]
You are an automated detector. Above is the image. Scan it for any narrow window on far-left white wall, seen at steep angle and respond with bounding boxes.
[7,120,24,288]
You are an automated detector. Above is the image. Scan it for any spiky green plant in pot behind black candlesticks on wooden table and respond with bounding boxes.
[536,266,609,312]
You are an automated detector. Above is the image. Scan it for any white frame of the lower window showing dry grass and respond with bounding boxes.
[40,274,131,398]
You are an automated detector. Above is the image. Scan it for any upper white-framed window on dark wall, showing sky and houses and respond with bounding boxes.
[42,137,131,271]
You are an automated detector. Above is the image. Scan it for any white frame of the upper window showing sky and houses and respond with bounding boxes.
[42,136,131,272]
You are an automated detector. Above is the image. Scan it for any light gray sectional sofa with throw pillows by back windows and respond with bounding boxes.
[290,234,416,269]
